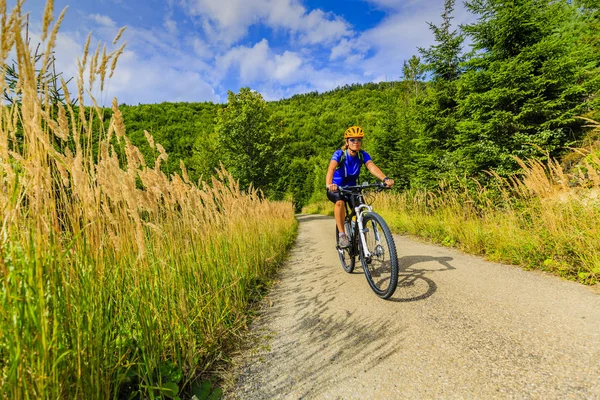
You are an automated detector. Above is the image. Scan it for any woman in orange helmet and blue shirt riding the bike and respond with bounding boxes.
[325,126,394,248]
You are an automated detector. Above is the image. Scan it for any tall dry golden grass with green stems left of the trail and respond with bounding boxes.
[0,0,295,399]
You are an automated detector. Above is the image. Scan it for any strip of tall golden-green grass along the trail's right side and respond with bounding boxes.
[375,145,600,284]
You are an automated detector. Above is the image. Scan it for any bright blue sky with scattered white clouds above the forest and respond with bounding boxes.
[9,0,474,104]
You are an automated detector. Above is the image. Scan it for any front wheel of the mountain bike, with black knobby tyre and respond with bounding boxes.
[360,212,398,299]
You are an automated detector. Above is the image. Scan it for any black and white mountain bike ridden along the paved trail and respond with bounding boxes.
[335,182,398,299]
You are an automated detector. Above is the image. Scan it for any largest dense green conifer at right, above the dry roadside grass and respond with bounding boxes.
[453,0,585,175]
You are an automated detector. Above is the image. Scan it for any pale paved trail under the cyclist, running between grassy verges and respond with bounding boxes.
[226,215,600,399]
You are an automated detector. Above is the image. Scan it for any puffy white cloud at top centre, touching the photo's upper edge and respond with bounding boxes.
[184,0,352,45]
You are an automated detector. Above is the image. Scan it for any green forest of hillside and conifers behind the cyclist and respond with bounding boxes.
[103,0,600,209]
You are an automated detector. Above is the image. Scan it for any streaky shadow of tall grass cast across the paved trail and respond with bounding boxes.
[248,264,406,399]
